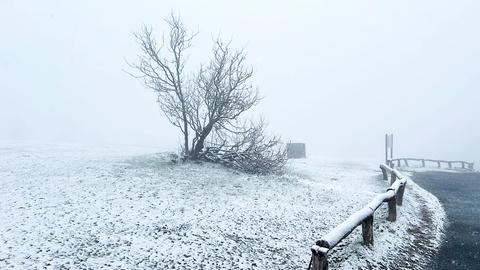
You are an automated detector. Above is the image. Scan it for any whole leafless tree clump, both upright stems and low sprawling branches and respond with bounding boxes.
[131,15,286,173]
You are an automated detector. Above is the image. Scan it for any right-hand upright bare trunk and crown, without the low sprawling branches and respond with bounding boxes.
[189,40,260,157]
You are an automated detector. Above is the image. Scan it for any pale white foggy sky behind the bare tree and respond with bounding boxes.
[0,0,480,166]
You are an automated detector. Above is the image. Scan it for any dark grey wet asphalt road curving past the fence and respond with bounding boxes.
[413,172,480,270]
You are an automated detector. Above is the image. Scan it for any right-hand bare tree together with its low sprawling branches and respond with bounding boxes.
[188,39,286,173]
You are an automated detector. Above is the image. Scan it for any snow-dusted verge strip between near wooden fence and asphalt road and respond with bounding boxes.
[330,171,446,270]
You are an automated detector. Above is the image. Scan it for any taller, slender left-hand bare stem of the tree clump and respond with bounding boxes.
[130,14,195,155]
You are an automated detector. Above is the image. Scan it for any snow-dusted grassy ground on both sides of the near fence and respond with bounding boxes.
[0,144,444,269]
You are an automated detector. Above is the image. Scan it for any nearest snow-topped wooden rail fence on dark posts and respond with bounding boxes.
[307,164,407,270]
